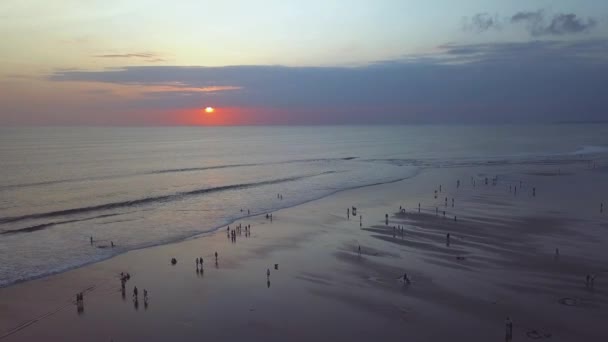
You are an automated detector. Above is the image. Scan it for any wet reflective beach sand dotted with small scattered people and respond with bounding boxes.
[0,162,608,342]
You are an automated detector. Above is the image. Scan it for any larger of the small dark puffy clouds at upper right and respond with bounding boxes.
[510,10,597,36]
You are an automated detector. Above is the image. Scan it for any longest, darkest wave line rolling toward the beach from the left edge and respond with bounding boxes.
[0,171,336,230]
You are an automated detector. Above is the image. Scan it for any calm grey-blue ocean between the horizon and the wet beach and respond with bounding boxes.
[0,124,608,287]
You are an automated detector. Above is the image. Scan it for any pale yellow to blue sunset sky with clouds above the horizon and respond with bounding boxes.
[0,0,608,126]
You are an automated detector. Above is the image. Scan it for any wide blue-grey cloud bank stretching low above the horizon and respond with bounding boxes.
[42,39,608,123]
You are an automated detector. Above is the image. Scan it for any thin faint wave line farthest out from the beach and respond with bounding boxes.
[0,157,358,190]
